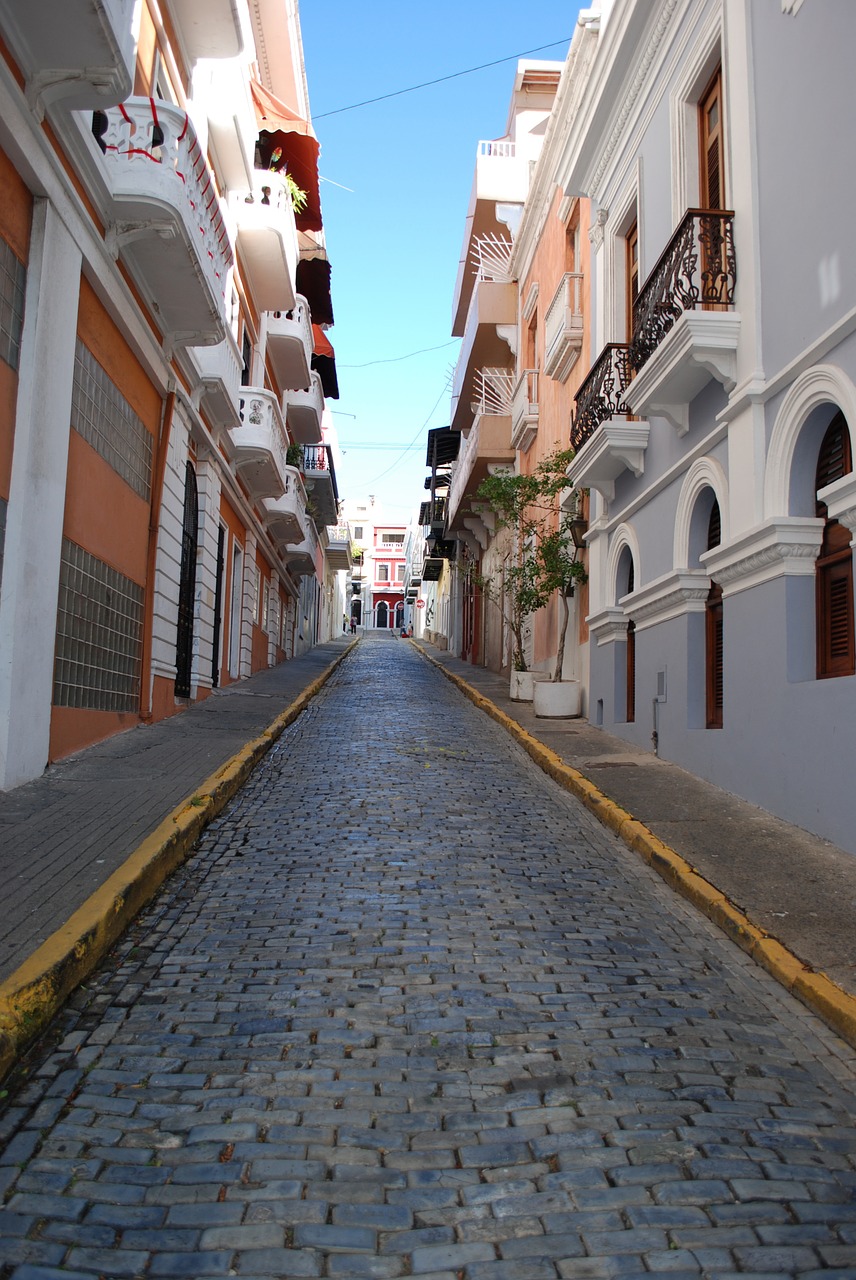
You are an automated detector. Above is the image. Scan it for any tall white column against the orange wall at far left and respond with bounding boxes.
[0,200,81,790]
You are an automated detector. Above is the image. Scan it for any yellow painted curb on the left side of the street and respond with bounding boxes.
[0,640,357,1079]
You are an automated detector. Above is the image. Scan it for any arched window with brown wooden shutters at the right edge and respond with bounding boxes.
[815,412,856,680]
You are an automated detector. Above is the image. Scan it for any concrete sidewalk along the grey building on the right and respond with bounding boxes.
[420,643,856,1029]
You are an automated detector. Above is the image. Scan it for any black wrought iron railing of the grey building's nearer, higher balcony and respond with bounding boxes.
[630,209,737,371]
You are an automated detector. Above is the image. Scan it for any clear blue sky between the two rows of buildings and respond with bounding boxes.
[301,0,578,524]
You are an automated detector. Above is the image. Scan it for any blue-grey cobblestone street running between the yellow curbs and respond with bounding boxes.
[0,636,856,1280]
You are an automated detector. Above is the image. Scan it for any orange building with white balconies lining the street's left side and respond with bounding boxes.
[0,0,348,788]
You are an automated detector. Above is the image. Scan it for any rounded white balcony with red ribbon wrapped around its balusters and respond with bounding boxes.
[92,97,232,347]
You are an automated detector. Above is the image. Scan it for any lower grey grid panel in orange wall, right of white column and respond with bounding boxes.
[54,539,143,712]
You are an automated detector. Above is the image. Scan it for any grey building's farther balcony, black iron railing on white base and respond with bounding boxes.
[568,342,649,502]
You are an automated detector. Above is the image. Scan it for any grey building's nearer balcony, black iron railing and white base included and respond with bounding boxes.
[627,209,741,435]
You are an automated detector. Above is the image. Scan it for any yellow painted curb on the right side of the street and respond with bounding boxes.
[416,645,856,1048]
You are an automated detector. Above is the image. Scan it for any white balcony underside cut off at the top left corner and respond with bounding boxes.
[0,0,136,110]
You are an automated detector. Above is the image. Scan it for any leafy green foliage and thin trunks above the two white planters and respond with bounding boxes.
[476,449,587,681]
